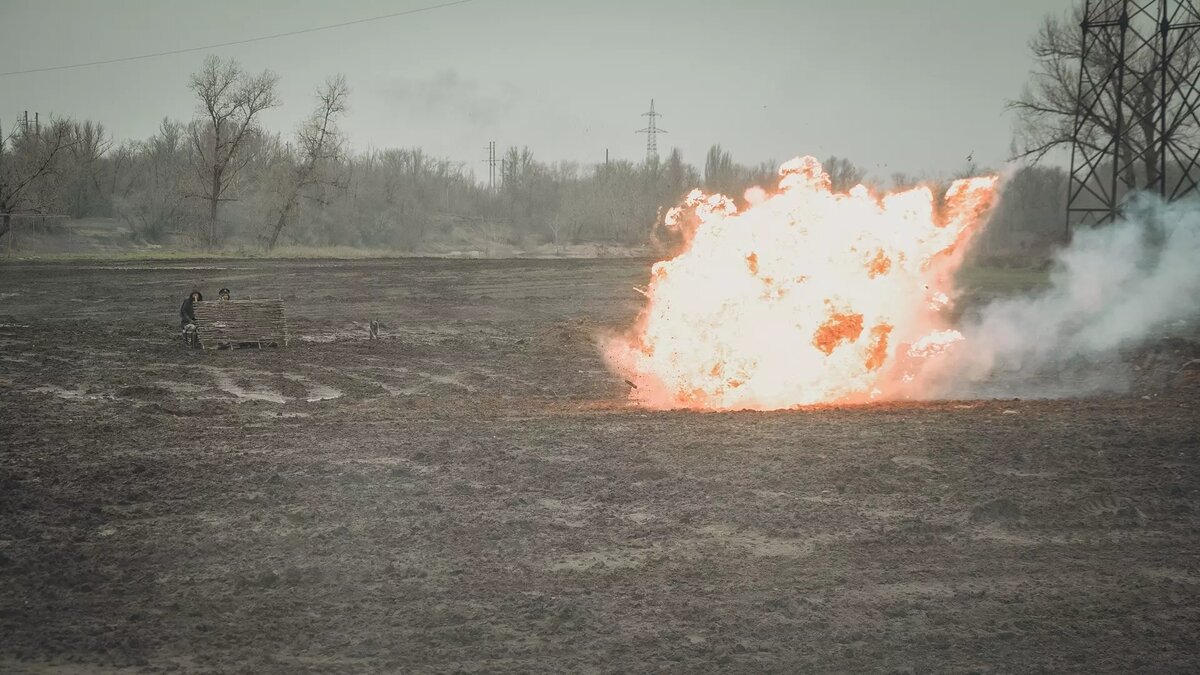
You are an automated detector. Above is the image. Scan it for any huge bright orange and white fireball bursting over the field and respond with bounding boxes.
[602,157,997,410]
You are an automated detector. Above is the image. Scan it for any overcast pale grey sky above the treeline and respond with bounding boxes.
[0,0,1072,178]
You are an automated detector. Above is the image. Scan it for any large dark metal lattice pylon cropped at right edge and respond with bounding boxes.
[1067,0,1200,229]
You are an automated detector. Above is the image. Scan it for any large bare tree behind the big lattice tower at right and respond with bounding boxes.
[1008,2,1200,185]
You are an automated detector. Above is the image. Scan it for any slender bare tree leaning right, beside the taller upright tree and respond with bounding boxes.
[266,74,350,251]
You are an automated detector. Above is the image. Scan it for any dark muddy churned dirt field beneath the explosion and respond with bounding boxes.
[0,259,1200,673]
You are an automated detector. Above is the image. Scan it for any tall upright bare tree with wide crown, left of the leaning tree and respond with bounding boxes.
[188,56,278,249]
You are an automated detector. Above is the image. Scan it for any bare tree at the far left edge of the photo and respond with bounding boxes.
[0,120,76,238]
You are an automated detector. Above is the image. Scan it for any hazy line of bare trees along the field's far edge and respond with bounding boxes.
[0,58,1066,255]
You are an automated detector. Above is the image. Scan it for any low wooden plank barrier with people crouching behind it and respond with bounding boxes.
[192,300,288,350]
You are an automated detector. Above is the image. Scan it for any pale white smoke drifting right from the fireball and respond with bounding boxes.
[922,196,1200,398]
